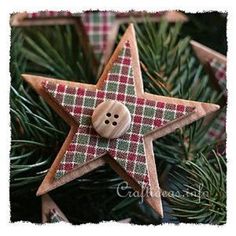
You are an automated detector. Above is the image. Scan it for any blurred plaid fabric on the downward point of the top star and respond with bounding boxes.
[81,11,115,57]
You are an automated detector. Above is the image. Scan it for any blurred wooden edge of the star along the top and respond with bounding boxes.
[10,11,188,76]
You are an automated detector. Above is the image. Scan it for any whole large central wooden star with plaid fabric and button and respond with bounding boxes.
[22,24,219,216]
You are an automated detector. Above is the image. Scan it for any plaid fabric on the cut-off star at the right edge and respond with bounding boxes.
[209,58,227,95]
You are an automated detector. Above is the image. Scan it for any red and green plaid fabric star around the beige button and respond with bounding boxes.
[43,41,194,192]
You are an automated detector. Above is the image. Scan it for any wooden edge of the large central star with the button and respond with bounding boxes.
[22,24,219,216]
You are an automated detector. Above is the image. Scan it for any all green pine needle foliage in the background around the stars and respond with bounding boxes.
[10,21,226,224]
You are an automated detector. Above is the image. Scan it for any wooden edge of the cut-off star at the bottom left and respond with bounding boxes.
[41,194,69,224]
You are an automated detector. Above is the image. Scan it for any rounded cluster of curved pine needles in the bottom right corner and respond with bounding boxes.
[169,152,226,224]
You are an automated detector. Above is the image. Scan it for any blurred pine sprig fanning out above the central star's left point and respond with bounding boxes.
[20,25,96,83]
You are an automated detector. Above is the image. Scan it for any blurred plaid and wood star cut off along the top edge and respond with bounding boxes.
[11,11,188,66]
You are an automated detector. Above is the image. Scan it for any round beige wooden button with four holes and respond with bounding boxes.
[92,100,131,139]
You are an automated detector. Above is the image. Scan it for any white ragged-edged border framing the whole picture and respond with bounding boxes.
[0,0,236,236]
